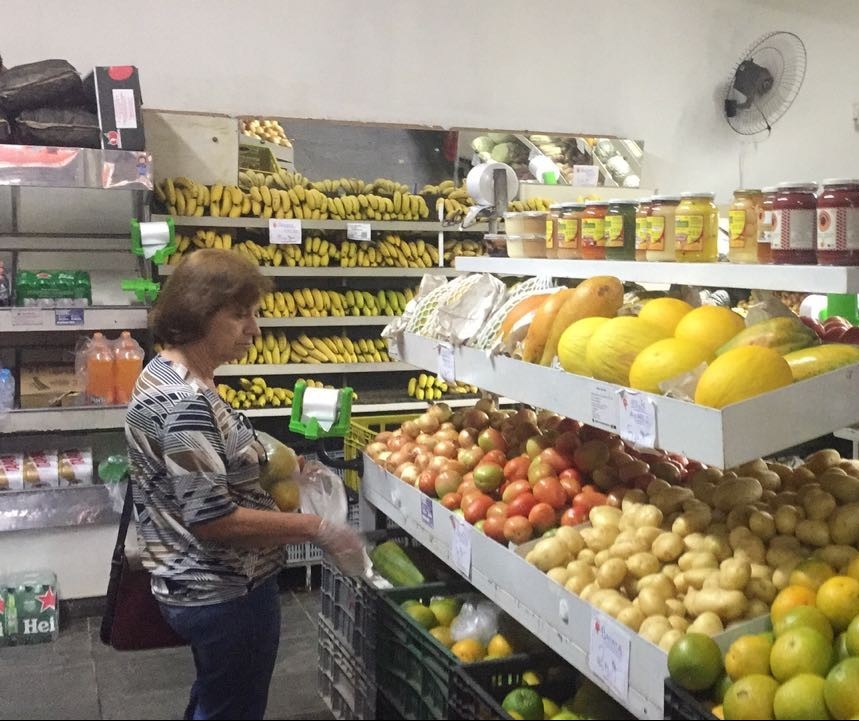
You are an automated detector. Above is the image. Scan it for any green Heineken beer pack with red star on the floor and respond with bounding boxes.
[0,572,60,646]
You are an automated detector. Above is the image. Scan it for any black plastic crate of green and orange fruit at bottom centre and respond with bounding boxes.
[448,651,579,719]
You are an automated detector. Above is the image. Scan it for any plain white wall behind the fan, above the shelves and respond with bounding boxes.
[2,0,859,196]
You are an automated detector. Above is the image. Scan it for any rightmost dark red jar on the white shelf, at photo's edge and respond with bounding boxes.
[817,179,859,265]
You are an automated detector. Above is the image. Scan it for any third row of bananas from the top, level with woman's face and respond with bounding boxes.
[260,288,415,318]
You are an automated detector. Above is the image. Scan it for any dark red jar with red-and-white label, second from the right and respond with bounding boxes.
[772,183,817,265]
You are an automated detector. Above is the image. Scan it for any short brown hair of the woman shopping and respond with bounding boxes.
[149,248,271,345]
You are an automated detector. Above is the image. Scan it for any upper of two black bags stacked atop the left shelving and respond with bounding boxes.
[0,60,84,114]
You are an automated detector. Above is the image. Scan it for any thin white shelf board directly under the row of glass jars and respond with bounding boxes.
[455,257,859,293]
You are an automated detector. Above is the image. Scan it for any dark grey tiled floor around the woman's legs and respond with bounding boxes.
[0,591,332,719]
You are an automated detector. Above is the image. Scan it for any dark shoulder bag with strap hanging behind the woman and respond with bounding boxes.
[100,479,188,651]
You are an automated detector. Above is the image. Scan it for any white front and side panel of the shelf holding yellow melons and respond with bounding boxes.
[392,334,859,468]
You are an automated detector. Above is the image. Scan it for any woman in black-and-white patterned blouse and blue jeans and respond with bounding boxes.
[126,250,362,719]
